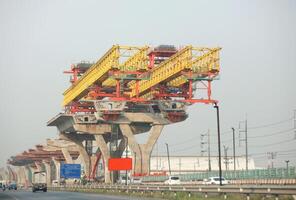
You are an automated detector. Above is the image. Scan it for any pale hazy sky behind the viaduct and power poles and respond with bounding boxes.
[0,0,296,167]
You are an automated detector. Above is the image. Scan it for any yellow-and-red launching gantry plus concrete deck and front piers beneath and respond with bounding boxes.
[48,45,221,182]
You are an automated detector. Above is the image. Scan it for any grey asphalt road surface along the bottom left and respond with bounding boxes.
[0,190,150,200]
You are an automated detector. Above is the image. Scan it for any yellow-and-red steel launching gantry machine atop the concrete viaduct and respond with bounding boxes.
[63,45,221,121]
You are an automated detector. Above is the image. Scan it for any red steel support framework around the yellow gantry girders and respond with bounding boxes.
[65,49,218,107]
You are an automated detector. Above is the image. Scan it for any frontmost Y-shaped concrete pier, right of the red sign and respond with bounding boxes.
[120,124,164,174]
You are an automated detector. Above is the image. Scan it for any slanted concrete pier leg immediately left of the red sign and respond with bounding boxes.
[95,135,111,183]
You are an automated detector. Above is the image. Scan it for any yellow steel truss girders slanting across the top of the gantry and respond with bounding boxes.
[63,45,221,106]
